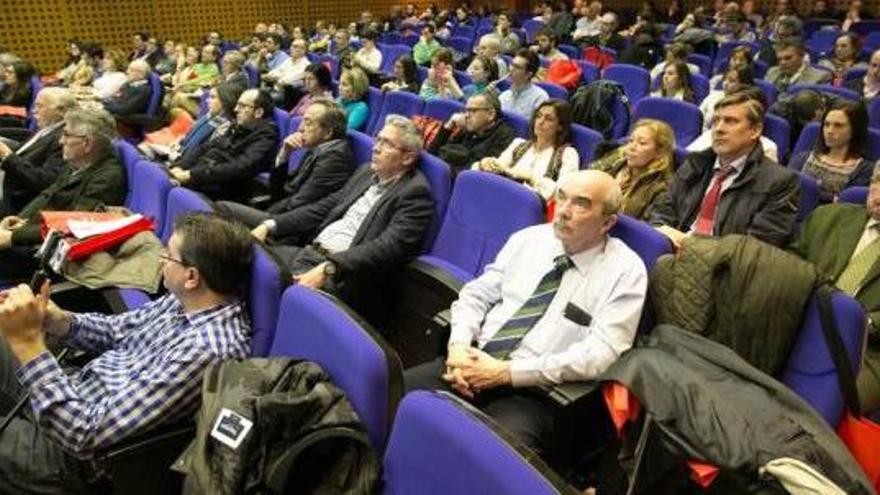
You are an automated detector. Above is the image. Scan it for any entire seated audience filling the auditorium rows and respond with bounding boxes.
[0,0,880,493]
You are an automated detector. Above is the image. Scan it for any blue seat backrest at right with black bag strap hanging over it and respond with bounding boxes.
[781,291,865,428]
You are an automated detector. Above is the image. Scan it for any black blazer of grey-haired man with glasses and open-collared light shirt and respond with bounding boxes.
[275,166,434,277]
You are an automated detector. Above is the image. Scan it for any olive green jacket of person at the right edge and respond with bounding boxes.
[791,203,880,340]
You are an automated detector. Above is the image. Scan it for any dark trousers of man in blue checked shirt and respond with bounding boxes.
[0,338,86,494]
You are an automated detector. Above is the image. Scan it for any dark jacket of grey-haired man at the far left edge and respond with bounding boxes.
[0,124,65,214]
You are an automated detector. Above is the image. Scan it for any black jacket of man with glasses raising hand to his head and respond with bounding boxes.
[429,120,516,172]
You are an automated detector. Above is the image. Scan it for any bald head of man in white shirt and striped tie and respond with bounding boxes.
[553,170,621,255]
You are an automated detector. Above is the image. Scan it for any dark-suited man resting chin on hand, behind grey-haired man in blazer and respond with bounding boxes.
[217,100,356,232]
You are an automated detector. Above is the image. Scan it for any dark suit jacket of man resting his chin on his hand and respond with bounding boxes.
[268,139,355,215]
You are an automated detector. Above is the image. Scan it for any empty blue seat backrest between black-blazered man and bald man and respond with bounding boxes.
[430,170,544,277]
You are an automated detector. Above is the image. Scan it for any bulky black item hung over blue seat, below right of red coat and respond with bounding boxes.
[571,79,630,140]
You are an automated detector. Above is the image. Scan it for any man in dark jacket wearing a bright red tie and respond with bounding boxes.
[651,93,800,246]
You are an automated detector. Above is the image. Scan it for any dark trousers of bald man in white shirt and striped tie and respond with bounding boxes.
[403,358,553,456]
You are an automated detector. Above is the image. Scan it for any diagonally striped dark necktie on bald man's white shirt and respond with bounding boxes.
[483,255,574,359]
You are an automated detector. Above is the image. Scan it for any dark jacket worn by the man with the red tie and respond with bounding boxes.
[651,145,800,246]
